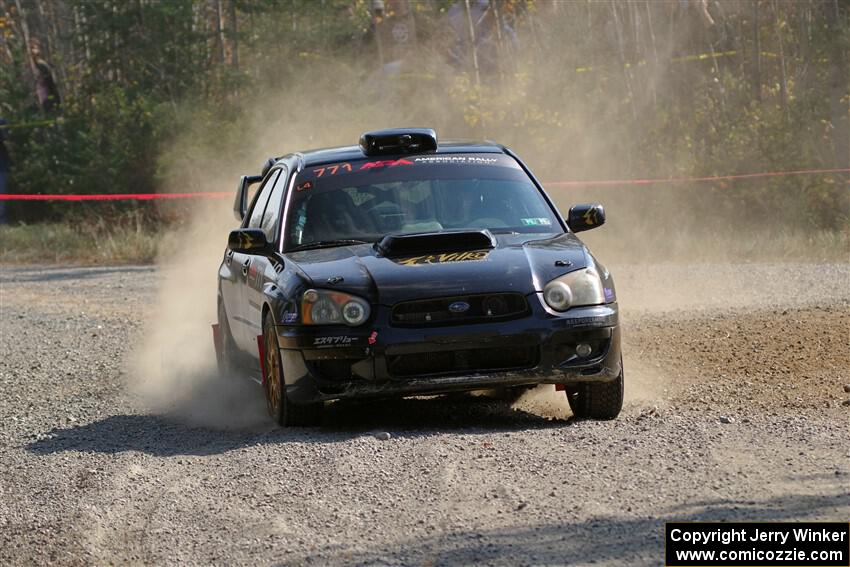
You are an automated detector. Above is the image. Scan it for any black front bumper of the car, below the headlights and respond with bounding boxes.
[277,296,621,403]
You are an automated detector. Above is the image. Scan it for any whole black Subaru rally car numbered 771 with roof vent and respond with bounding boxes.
[213,128,623,425]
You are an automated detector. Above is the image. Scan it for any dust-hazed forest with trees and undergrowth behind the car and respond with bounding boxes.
[0,0,850,262]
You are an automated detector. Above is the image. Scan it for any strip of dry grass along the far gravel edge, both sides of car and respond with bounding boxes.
[0,217,850,265]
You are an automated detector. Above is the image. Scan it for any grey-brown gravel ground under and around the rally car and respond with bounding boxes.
[0,264,850,565]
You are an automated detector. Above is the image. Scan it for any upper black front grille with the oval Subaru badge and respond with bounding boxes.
[391,293,529,327]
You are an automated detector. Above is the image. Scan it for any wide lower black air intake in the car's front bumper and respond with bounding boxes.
[387,346,539,376]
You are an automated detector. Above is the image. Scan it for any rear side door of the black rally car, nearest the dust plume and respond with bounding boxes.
[228,169,280,353]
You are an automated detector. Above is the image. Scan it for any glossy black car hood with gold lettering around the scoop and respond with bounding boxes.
[287,233,593,305]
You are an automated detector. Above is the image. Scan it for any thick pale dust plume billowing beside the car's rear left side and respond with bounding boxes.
[132,203,266,428]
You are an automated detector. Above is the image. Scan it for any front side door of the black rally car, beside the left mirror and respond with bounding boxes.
[240,168,289,344]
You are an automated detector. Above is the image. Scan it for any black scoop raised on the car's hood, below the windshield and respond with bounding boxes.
[375,229,496,258]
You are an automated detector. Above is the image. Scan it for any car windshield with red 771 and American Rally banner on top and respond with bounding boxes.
[285,153,563,250]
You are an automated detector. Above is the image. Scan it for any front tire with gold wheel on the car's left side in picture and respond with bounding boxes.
[263,314,324,427]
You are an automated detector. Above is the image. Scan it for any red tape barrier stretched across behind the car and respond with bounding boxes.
[0,168,850,201]
